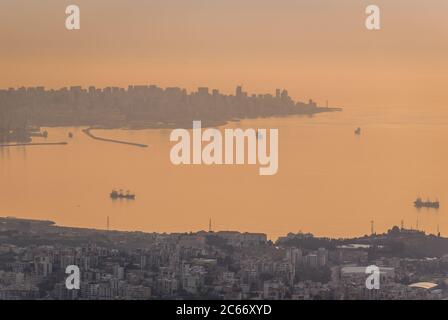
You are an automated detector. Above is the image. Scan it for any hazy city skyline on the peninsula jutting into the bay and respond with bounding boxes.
[0,85,341,142]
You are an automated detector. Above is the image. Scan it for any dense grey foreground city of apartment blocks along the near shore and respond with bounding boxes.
[0,218,448,300]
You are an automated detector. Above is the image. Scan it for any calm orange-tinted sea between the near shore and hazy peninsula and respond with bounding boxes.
[0,108,448,238]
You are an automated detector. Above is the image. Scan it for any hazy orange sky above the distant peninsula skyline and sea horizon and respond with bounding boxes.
[0,0,448,108]
